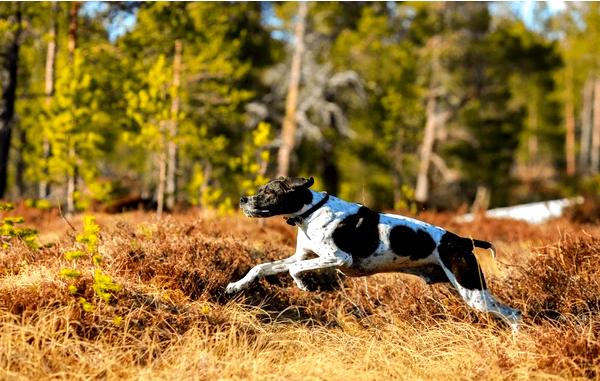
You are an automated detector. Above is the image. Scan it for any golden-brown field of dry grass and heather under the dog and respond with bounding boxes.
[0,208,600,380]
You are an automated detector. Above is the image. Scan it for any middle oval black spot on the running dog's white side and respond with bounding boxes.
[390,225,435,261]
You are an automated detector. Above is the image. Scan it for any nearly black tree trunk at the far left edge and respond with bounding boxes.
[0,2,22,198]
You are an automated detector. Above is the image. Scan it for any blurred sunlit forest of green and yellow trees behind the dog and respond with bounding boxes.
[0,2,600,213]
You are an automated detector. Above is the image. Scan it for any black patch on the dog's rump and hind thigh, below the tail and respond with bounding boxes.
[438,232,487,290]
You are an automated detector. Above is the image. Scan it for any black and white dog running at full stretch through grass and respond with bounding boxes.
[226,177,521,329]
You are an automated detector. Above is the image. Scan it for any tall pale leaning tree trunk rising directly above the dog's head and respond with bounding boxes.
[277,1,308,176]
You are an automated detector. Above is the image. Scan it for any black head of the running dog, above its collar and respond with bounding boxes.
[240,177,315,217]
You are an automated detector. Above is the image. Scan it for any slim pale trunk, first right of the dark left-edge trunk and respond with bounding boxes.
[38,1,58,199]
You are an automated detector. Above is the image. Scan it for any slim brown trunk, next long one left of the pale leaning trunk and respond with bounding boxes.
[166,39,183,210]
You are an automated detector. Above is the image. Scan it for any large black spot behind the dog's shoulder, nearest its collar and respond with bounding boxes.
[332,206,380,258]
